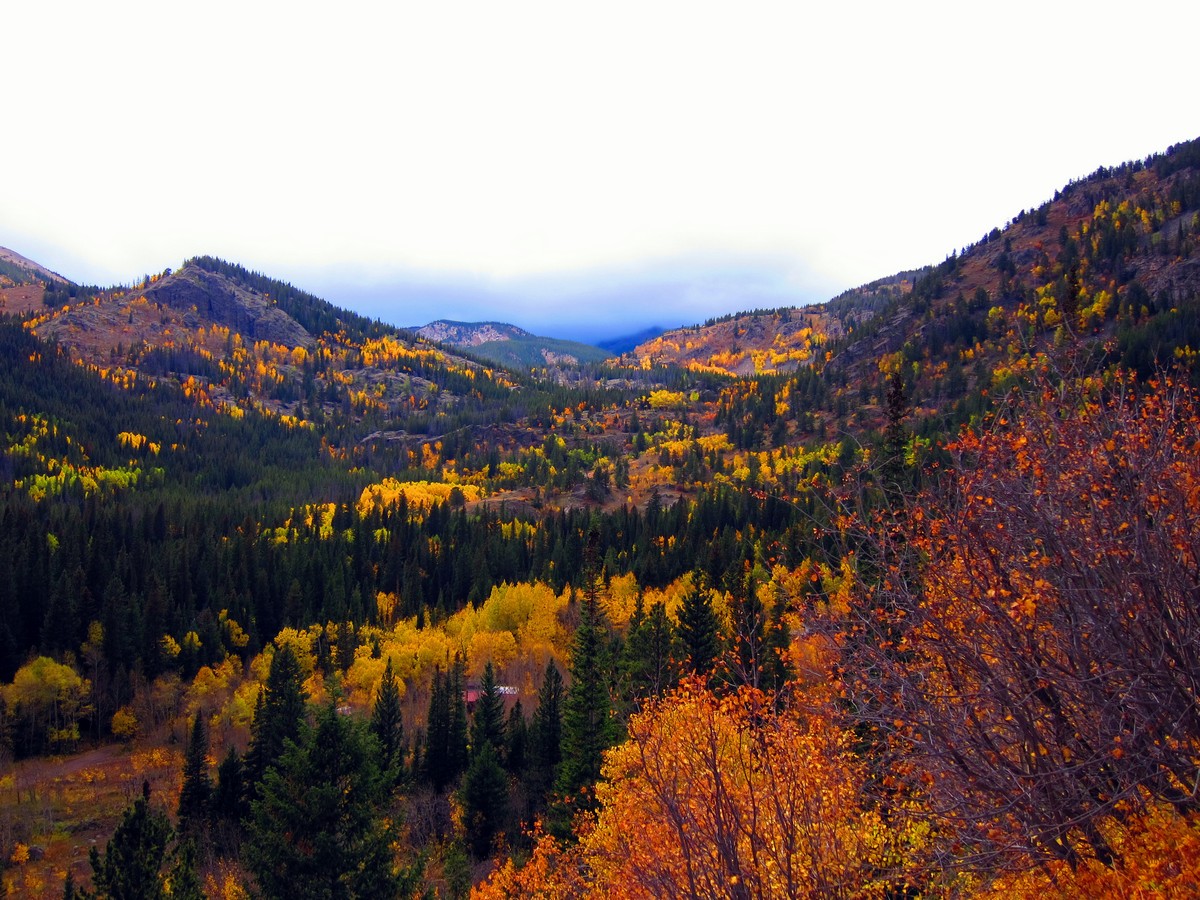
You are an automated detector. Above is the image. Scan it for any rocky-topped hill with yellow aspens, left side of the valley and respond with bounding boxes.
[26,257,530,441]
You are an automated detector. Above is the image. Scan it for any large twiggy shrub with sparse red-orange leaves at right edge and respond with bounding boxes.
[847,367,1200,868]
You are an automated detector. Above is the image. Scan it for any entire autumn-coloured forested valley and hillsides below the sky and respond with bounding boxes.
[0,142,1200,898]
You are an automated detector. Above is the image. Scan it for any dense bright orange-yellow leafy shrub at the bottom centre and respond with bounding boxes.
[597,683,894,898]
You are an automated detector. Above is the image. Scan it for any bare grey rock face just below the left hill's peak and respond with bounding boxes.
[144,265,312,348]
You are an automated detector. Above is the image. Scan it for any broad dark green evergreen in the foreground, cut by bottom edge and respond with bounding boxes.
[245,704,400,900]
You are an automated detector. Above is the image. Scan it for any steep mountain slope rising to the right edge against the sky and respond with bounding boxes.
[622,140,1200,443]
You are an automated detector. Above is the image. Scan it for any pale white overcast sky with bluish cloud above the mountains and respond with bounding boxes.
[0,0,1200,340]
